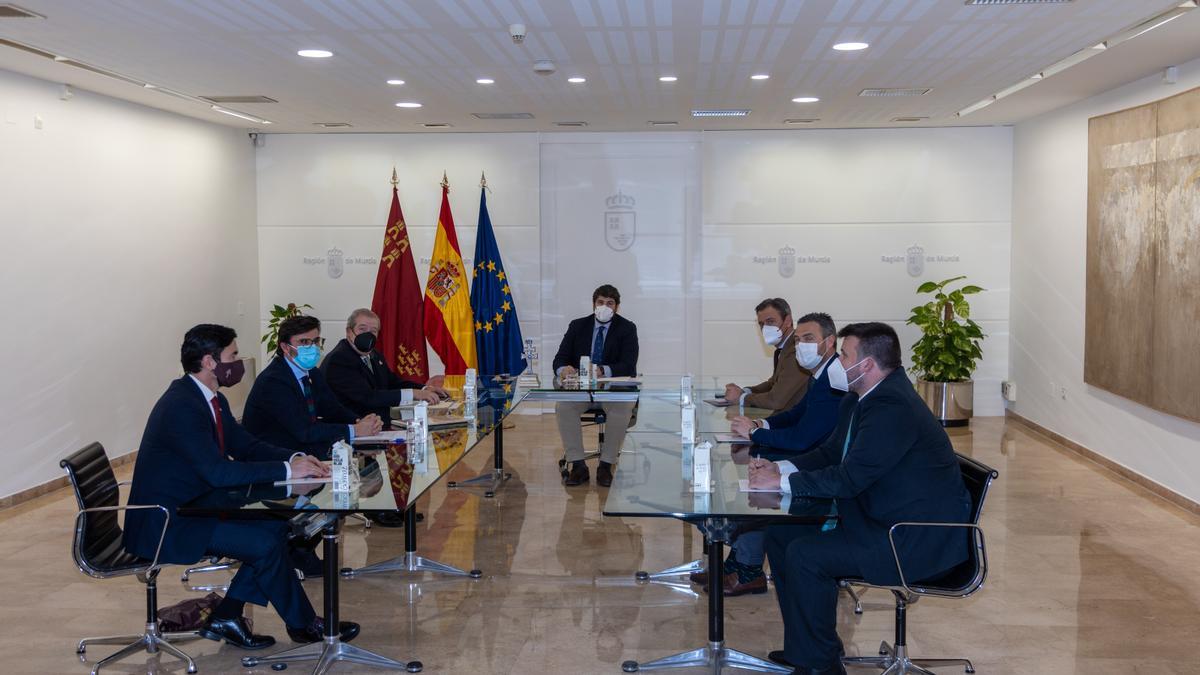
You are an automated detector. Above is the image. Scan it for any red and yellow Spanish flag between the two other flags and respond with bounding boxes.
[424,173,475,375]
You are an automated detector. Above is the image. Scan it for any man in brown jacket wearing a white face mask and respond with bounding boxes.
[725,298,811,412]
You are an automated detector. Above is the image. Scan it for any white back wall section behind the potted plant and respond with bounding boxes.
[703,127,1012,416]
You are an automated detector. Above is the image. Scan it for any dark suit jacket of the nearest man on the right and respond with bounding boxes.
[788,368,971,584]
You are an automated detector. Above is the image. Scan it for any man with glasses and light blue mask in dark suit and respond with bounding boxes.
[242,316,383,459]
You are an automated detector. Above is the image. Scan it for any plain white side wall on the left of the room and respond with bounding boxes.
[0,71,258,495]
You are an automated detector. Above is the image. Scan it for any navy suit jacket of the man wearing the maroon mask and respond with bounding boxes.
[125,375,292,563]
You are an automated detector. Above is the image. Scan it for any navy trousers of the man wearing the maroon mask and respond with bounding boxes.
[205,520,317,628]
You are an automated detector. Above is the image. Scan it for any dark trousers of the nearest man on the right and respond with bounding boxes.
[766,525,859,670]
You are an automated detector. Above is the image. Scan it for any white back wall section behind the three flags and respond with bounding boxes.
[258,133,541,374]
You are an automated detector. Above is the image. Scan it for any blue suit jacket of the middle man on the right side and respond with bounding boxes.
[750,357,842,459]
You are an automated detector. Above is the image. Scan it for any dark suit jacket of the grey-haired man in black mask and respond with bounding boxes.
[320,340,424,423]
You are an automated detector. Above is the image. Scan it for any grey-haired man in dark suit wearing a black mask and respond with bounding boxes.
[320,307,449,426]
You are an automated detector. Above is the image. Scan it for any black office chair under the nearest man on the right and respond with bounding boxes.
[841,455,1000,675]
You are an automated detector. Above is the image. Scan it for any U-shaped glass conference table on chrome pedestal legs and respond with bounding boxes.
[179,378,820,674]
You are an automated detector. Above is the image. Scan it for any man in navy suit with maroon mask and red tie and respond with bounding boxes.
[125,324,359,649]
